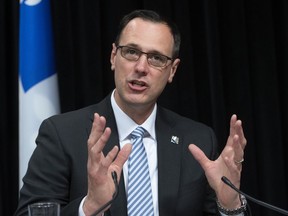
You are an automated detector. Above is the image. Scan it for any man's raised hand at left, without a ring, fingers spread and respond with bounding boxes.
[83,113,132,215]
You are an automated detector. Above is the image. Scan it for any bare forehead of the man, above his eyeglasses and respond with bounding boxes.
[119,18,174,54]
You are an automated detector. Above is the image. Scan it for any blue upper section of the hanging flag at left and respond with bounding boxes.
[19,0,55,92]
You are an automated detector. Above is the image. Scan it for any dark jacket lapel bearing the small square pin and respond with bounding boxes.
[156,109,182,215]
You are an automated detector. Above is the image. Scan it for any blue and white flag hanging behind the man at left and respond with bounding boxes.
[19,0,60,188]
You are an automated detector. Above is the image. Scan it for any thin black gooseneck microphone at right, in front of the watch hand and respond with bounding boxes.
[221,176,288,215]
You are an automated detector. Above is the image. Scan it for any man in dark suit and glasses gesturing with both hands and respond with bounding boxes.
[16,10,246,216]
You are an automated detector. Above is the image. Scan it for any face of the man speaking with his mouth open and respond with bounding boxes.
[110,18,180,110]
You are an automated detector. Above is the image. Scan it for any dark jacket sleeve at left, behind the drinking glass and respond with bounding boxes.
[15,119,85,216]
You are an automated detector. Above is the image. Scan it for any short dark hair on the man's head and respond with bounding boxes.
[115,10,181,58]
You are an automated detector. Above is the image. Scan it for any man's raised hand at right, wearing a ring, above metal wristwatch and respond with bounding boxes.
[189,115,247,209]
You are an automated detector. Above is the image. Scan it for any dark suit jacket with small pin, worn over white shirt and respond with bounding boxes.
[15,95,218,216]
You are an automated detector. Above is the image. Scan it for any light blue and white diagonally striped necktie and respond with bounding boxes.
[127,126,154,216]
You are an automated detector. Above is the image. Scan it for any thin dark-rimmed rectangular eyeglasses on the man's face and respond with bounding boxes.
[117,46,173,68]
